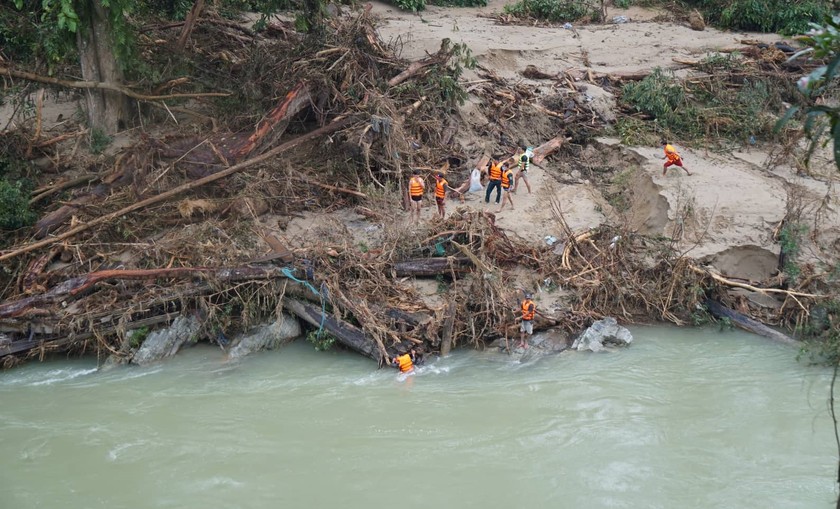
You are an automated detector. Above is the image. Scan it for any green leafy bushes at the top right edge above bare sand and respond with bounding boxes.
[686,0,831,34]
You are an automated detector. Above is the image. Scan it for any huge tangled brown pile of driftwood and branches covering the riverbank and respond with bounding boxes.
[0,6,832,366]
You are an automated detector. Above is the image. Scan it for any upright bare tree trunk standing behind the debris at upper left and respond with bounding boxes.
[76,0,129,135]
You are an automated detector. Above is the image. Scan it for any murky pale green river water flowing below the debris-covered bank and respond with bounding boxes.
[0,327,837,509]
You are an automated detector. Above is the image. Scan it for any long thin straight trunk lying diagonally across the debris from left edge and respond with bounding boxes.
[0,117,352,261]
